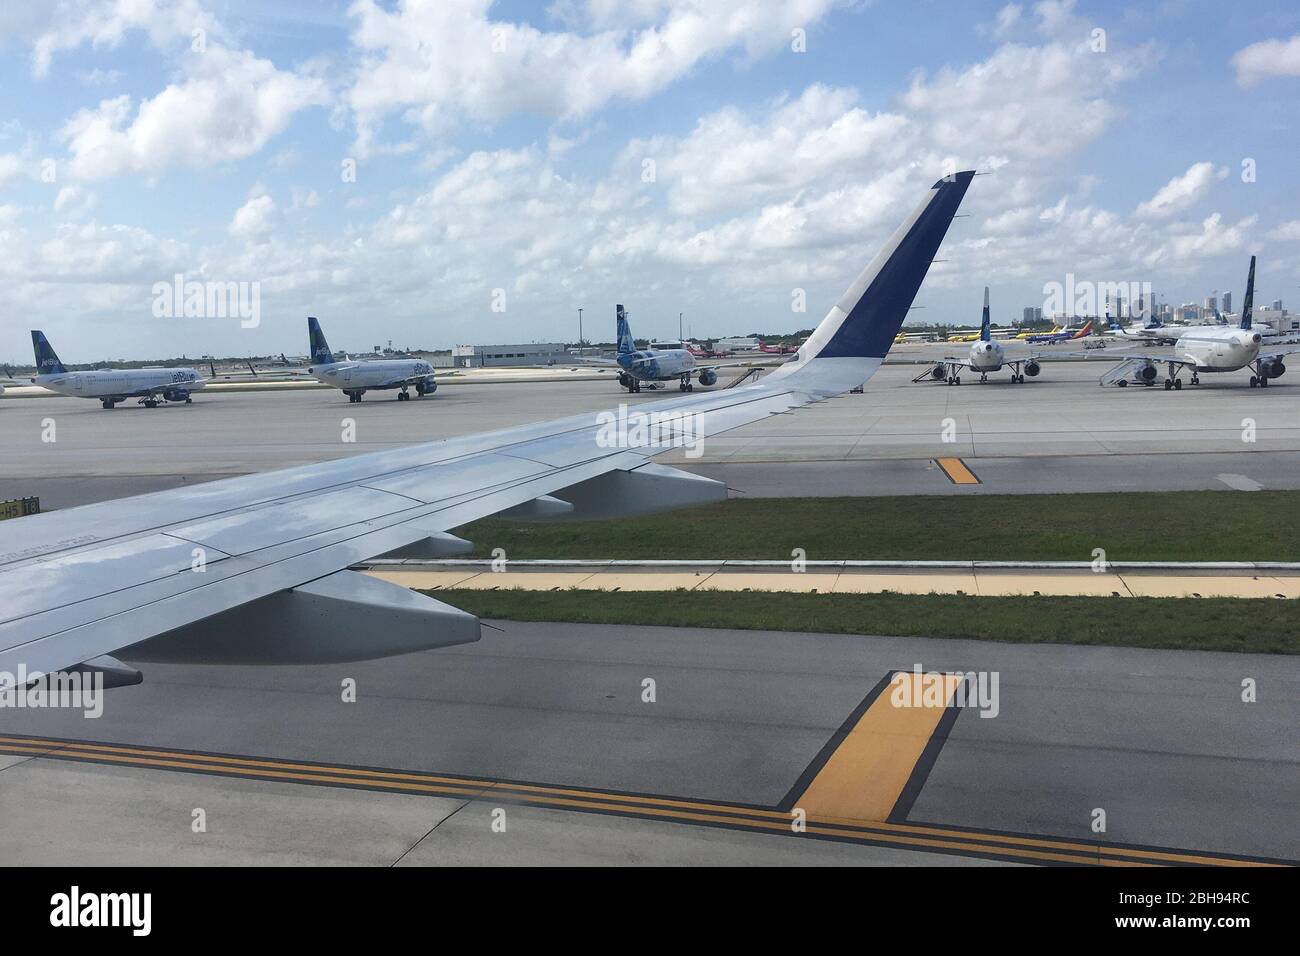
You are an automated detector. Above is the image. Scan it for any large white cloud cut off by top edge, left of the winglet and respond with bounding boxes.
[347,0,835,153]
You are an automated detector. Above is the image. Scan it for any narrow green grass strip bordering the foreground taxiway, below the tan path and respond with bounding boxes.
[425,589,1300,654]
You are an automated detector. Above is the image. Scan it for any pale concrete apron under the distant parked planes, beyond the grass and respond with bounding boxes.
[0,362,1300,507]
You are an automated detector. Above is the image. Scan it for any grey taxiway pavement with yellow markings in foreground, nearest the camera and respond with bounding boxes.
[0,622,1300,865]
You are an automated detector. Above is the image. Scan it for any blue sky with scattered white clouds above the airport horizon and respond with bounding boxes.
[0,0,1300,362]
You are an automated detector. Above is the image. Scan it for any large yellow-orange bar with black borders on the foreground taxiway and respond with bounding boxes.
[794,671,962,822]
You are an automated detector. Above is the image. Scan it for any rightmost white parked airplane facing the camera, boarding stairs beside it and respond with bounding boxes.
[1101,256,1300,390]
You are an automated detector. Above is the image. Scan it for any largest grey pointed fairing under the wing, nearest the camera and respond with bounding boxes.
[122,571,480,665]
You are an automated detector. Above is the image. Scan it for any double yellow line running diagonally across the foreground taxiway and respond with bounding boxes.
[0,735,1271,866]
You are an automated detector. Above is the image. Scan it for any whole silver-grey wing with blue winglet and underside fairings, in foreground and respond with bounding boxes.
[0,172,974,685]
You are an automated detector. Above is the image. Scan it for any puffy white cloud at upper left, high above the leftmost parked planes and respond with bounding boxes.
[60,46,325,179]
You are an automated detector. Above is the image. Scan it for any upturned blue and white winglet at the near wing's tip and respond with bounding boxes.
[767,169,975,394]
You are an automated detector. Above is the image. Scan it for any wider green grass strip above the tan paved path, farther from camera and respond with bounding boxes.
[456,490,1300,561]
